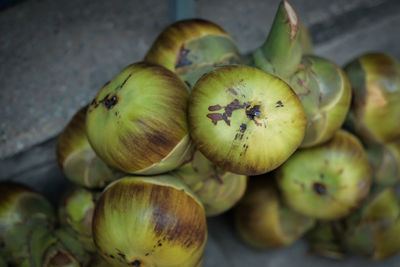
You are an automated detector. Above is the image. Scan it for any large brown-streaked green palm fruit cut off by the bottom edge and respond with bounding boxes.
[93,177,207,267]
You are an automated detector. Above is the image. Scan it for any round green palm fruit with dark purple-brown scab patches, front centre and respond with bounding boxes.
[189,63,306,175]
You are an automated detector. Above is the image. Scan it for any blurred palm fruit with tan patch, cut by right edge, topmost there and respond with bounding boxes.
[344,53,400,144]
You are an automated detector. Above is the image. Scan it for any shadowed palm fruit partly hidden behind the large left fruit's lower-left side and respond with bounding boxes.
[56,106,121,188]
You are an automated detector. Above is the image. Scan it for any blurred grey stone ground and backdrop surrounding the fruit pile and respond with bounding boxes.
[0,0,400,267]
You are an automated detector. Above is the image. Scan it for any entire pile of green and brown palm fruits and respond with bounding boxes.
[0,0,400,267]
